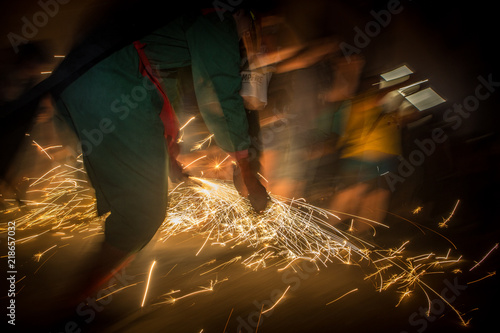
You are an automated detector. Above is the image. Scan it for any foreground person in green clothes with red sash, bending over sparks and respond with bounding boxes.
[54,10,269,304]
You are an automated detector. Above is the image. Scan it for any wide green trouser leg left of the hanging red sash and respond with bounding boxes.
[56,46,168,252]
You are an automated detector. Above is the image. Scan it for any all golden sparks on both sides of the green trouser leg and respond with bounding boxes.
[1,137,476,324]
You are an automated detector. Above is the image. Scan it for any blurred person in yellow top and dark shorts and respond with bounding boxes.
[329,73,417,234]
